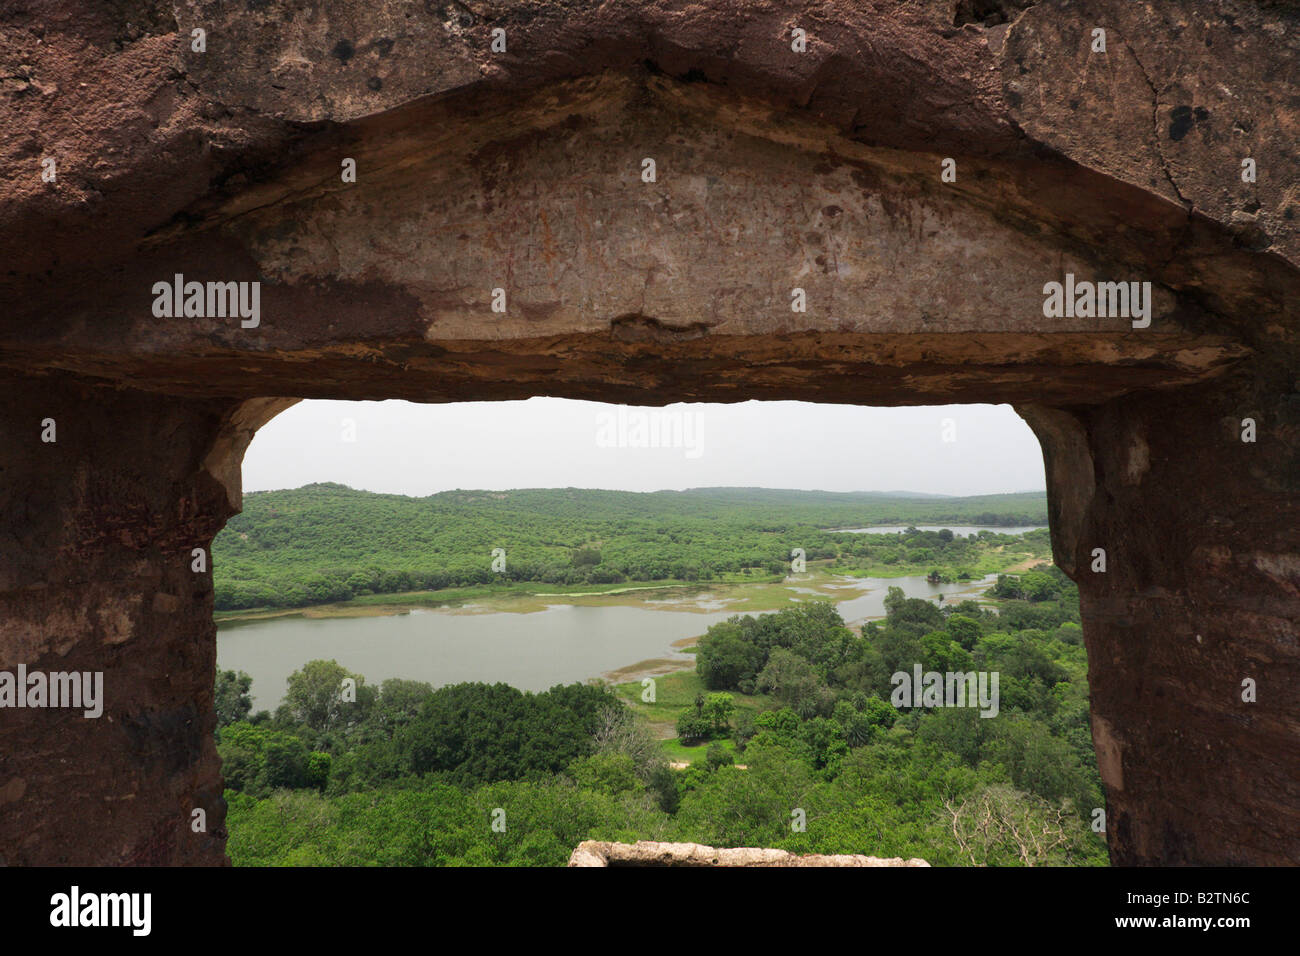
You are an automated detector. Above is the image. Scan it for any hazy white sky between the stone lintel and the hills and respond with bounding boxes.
[243,398,1045,496]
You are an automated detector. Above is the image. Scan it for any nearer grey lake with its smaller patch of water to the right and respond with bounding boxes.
[217,572,997,710]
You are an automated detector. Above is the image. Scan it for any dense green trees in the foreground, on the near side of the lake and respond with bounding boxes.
[217,561,1106,866]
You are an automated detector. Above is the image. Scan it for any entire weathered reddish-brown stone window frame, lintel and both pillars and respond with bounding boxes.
[0,0,1300,864]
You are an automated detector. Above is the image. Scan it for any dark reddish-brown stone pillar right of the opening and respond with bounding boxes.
[1053,378,1300,865]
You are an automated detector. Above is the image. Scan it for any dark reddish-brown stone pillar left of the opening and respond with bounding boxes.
[0,376,239,865]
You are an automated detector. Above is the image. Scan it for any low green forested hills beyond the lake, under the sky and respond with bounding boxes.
[213,484,1047,609]
